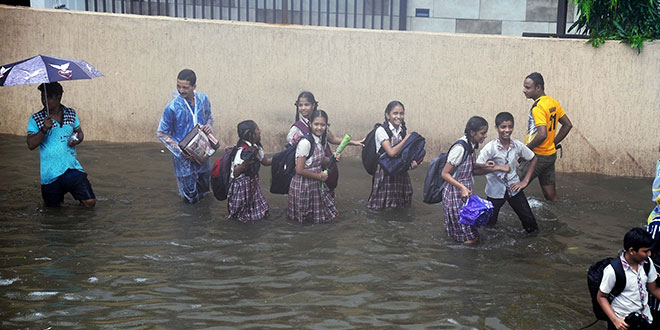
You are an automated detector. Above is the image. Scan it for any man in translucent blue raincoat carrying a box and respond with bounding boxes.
[157,69,213,203]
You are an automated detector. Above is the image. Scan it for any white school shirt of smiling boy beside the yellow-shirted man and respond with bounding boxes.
[477,138,534,198]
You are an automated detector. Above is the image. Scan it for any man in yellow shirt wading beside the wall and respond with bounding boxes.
[520,72,573,201]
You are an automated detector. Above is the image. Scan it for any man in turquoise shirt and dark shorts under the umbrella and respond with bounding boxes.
[27,82,96,207]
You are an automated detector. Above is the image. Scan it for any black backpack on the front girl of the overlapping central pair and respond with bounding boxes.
[270,134,316,195]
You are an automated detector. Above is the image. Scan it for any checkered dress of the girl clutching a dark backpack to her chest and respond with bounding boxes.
[367,136,412,210]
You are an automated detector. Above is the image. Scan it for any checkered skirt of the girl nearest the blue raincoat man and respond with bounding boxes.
[227,174,270,222]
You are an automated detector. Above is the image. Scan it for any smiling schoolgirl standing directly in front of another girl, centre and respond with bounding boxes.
[287,110,340,223]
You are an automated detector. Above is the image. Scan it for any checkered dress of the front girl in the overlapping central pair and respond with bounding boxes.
[286,138,339,223]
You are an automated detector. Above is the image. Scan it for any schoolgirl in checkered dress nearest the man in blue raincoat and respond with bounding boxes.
[227,120,272,222]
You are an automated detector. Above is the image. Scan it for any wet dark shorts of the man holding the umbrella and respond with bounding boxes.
[41,169,96,206]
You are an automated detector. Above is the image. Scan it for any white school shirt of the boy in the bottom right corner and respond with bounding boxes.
[598,259,658,322]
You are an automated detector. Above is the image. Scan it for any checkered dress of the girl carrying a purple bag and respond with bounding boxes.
[442,154,479,243]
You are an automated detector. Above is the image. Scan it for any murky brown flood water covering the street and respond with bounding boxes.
[0,135,655,329]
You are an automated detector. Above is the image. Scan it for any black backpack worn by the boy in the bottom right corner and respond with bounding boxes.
[587,257,651,321]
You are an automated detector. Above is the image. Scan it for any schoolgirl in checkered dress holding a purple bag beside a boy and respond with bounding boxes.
[442,116,509,244]
